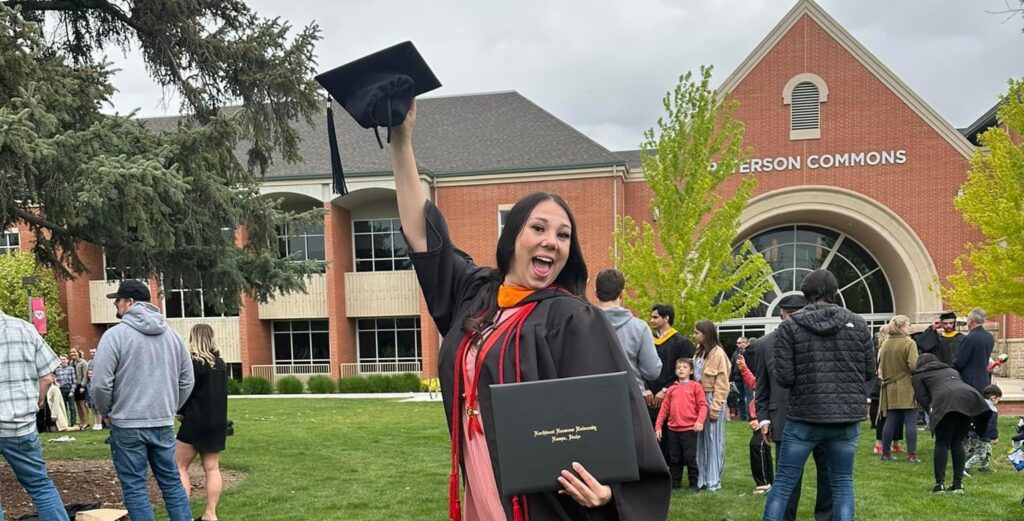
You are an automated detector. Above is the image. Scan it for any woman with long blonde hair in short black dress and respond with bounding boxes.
[175,323,227,521]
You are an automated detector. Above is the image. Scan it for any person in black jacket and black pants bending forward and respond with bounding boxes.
[912,353,991,493]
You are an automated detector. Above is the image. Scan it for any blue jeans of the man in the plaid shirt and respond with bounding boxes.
[0,432,68,521]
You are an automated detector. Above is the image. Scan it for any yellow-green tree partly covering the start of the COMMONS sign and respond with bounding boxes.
[615,67,772,332]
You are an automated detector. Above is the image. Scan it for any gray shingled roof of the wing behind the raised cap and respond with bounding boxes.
[143,91,625,179]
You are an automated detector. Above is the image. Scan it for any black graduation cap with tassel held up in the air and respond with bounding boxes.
[316,42,441,194]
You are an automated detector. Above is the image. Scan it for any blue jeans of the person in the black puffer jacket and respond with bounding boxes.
[764,420,860,521]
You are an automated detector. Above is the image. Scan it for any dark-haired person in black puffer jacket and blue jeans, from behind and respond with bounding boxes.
[764,269,876,521]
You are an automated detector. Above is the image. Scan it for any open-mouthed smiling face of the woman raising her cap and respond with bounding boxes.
[505,200,572,290]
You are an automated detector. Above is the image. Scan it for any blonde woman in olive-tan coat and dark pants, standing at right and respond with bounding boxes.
[879,315,918,463]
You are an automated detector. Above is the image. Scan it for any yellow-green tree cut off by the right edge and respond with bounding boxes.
[942,80,1024,314]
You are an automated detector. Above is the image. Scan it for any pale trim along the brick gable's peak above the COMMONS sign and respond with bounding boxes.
[719,0,974,158]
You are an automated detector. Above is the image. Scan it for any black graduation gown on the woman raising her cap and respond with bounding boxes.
[411,202,671,521]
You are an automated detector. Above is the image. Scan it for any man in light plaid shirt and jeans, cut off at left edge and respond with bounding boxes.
[0,311,69,521]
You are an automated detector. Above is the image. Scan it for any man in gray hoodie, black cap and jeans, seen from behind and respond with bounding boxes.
[89,280,195,521]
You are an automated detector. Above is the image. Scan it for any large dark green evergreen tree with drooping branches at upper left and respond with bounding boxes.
[0,0,318,308]
